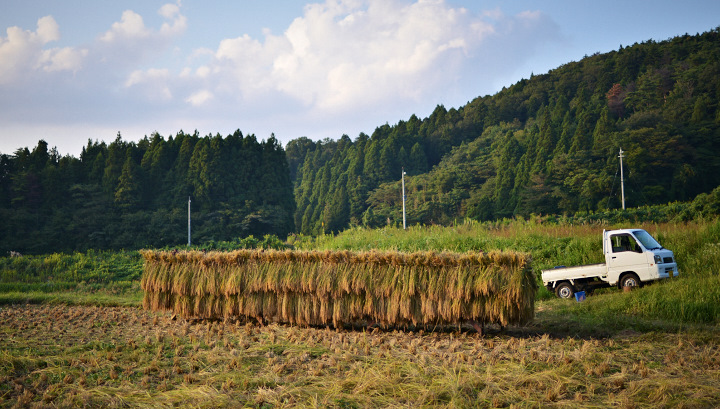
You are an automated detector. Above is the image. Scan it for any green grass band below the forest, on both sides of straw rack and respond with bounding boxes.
[5,217,720,322]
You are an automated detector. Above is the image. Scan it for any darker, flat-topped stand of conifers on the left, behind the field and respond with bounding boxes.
[0,131,295,252]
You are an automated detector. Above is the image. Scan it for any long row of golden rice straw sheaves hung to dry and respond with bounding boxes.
[142,250,537,327]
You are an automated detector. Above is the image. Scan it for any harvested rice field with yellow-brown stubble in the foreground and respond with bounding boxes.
[0,303,720,408]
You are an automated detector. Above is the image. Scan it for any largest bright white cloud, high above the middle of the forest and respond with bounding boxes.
[190,0,516,112]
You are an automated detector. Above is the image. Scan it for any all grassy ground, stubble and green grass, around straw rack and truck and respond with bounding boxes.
[0,221,720,408]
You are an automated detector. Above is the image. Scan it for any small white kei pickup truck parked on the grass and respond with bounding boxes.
[542,229,678,298]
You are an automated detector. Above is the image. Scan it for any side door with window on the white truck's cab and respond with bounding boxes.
[607,233,650,284]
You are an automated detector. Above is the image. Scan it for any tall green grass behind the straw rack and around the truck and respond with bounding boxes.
[293,219,720,323]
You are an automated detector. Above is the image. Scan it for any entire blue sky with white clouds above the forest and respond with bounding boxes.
[0,0,720,157]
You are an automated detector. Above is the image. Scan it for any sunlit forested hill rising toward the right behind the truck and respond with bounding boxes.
[286,29,720,234]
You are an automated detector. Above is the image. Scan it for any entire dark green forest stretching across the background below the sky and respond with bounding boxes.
[0,29,720,252]
